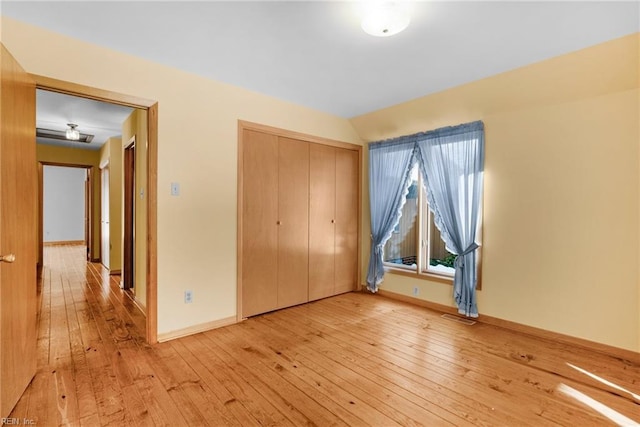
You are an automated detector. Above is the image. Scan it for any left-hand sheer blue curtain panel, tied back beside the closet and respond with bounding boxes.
[367,137,417,292]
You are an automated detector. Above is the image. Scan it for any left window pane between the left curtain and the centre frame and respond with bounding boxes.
[384,167,419,270]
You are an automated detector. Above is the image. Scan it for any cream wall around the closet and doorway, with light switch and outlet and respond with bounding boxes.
[2,17,368,334]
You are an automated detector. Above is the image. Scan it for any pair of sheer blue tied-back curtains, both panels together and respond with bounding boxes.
[367,121,484,317]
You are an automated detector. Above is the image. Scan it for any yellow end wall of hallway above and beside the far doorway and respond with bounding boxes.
[36,144,101,259]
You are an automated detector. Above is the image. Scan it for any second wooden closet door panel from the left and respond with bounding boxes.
[278,138,309,308]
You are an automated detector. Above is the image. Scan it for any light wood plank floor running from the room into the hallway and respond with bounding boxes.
[6,246,640,426]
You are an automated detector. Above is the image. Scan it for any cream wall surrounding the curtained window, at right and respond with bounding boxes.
[351,34,640,351]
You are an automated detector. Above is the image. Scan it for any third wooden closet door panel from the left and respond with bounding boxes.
[309,144,336,301]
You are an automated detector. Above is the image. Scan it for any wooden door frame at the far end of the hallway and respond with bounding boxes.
[38,161,94,260]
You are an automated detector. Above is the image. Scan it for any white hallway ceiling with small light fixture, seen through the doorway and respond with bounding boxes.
[36,89,133,150]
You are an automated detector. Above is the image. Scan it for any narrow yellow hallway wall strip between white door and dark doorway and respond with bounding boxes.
[100,137,122,273]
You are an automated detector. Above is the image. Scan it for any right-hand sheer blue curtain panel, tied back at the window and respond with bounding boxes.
[417,121,484,317]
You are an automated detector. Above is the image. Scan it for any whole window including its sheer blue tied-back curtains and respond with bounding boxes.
[367,120,484,317]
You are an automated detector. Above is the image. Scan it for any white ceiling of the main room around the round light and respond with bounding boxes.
[2,0,640,118]
